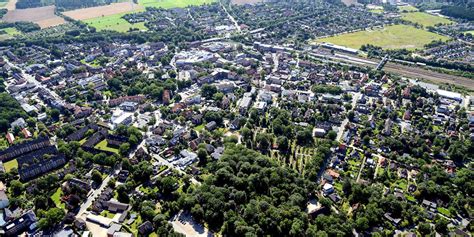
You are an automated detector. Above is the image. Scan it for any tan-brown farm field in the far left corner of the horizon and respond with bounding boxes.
[3,6,66,28]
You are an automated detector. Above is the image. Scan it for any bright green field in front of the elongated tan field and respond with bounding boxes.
[84,13,147,32]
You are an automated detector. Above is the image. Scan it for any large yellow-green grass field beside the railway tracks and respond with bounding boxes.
[317,25,448,50]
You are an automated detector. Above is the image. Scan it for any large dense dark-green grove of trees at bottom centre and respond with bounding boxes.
[182,146,308,236]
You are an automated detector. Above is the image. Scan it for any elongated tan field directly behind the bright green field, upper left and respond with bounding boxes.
[63,2,143,20]
